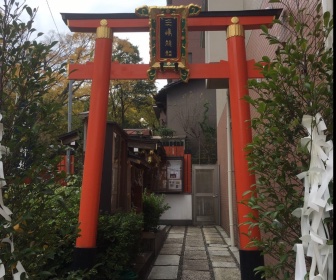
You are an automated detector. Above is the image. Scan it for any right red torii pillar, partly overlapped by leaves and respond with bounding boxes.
[227,17,263,280]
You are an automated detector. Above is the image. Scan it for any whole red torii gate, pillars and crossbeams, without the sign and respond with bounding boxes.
[62,7,282,280]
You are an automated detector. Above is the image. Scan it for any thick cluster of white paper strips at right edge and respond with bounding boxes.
[292,113,333,280]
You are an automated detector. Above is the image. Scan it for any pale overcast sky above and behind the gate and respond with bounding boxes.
[24,0,167,88]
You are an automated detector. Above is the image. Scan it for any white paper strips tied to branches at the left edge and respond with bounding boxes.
[0,114,28,280]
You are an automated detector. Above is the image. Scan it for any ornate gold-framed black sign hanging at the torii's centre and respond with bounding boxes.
[135,4,201,82]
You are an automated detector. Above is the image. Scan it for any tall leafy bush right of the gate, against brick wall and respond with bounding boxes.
[246,0,333,280]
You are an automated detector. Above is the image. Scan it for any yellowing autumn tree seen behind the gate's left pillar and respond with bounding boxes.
[45,31,157,130]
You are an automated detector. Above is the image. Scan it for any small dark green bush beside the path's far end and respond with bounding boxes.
[142,189,170,232]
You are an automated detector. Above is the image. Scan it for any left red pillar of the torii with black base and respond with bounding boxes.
[74,19,112,268]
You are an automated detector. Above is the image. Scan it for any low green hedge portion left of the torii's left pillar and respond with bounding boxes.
[1,176,84,279]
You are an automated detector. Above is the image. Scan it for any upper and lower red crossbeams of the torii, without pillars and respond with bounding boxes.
[61,9,282,80]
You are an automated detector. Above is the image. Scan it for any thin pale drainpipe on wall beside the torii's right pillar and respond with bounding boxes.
[226,93,235,246]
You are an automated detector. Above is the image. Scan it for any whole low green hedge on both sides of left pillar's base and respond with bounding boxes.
[0,176,143,280]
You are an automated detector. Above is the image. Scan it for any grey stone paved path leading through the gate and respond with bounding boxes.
[147,226,241,280]
